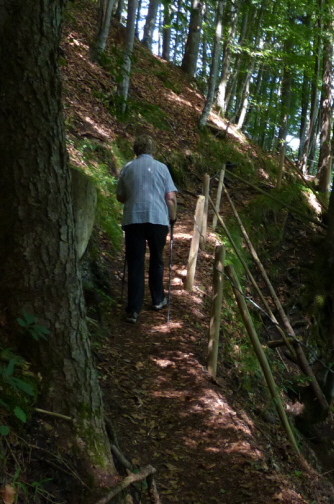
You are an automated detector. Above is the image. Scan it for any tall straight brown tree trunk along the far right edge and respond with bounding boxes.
[318,0,333,194]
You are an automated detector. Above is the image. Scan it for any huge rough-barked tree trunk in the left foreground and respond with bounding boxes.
[0,0,114,482]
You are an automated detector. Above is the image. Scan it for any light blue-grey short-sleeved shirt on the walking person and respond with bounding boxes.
[117,154,177,226]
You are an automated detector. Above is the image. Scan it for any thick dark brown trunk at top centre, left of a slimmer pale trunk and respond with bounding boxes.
[182,0,203,77]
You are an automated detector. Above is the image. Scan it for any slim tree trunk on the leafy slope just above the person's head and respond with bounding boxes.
[118,0,138,113]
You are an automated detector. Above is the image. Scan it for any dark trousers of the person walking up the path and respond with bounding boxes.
[124,223,168,313]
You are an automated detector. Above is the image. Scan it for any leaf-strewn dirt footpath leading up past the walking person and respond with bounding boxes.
[98,200,333,504]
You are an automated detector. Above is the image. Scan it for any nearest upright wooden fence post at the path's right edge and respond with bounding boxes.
[206,245,225,378]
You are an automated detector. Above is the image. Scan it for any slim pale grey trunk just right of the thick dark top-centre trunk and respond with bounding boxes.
[199,0,224,126]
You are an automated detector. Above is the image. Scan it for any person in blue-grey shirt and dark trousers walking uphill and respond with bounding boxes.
[117,135,177,324]
